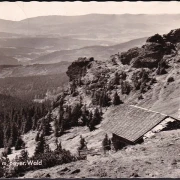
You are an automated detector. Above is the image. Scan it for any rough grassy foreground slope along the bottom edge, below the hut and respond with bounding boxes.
[24,127,180,178]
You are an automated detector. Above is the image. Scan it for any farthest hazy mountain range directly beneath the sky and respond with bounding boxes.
[0,14,180,43]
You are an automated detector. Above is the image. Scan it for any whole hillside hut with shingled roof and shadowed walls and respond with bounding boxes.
[102,105,180,150]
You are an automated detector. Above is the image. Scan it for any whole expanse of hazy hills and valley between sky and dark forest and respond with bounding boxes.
[0,14,180,65]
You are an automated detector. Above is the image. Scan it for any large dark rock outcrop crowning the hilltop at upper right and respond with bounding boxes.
[120,34,177,69]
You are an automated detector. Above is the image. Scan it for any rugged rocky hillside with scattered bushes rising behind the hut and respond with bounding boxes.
[61,29,180,117]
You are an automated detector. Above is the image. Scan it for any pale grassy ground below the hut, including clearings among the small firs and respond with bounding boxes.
[4,94,180,178]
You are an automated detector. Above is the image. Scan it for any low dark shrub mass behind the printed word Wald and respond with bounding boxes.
[3,143,77,177]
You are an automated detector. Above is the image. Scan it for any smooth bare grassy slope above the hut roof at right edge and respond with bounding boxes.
[138,63,180,118]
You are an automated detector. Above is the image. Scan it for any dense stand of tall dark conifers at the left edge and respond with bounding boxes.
[0,103,49,154]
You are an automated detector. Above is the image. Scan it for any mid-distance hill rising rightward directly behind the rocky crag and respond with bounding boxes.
[30,37,147,64]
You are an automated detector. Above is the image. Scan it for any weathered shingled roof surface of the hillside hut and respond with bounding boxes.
[102,105,167,142]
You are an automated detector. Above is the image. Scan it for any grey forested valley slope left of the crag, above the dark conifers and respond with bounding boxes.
[0,73,68,101]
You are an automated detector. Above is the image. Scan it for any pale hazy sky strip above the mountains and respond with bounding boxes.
[0,1,180,21]
